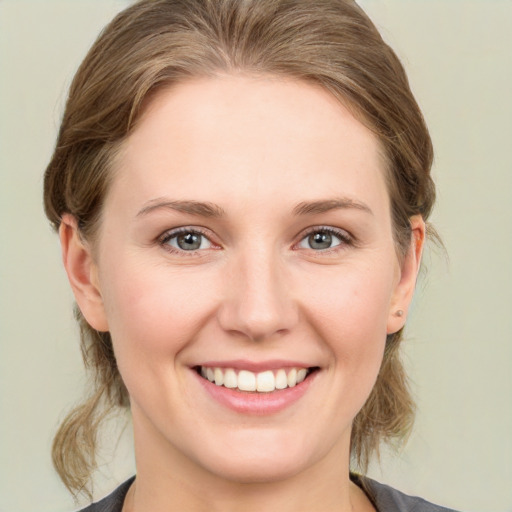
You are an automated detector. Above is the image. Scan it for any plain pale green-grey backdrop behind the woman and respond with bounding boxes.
[0,0,512,512]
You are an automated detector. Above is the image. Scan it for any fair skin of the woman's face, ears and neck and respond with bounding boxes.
[60,76,425,512]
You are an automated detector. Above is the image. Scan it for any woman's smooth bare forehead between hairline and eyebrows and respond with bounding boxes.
[114,75,387,213]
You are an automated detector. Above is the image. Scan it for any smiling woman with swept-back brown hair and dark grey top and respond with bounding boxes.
[45,0,456,512]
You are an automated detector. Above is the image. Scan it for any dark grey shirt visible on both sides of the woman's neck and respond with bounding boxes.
[81,477,455,512]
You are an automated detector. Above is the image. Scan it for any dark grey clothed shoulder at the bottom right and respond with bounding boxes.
[358,478,455,512]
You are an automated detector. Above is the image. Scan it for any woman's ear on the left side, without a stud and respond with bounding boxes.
[59,214,109,331]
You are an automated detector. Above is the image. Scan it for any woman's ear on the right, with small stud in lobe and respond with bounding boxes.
[387,215,426,334]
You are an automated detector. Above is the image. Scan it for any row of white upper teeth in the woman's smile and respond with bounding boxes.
[200,366,308,393]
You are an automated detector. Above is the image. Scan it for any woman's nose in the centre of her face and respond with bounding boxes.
[218,251,299,341]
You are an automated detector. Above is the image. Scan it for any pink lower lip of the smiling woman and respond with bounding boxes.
[192,370,319,416]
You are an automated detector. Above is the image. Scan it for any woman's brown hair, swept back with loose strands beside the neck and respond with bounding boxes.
[44,0,435,498]
